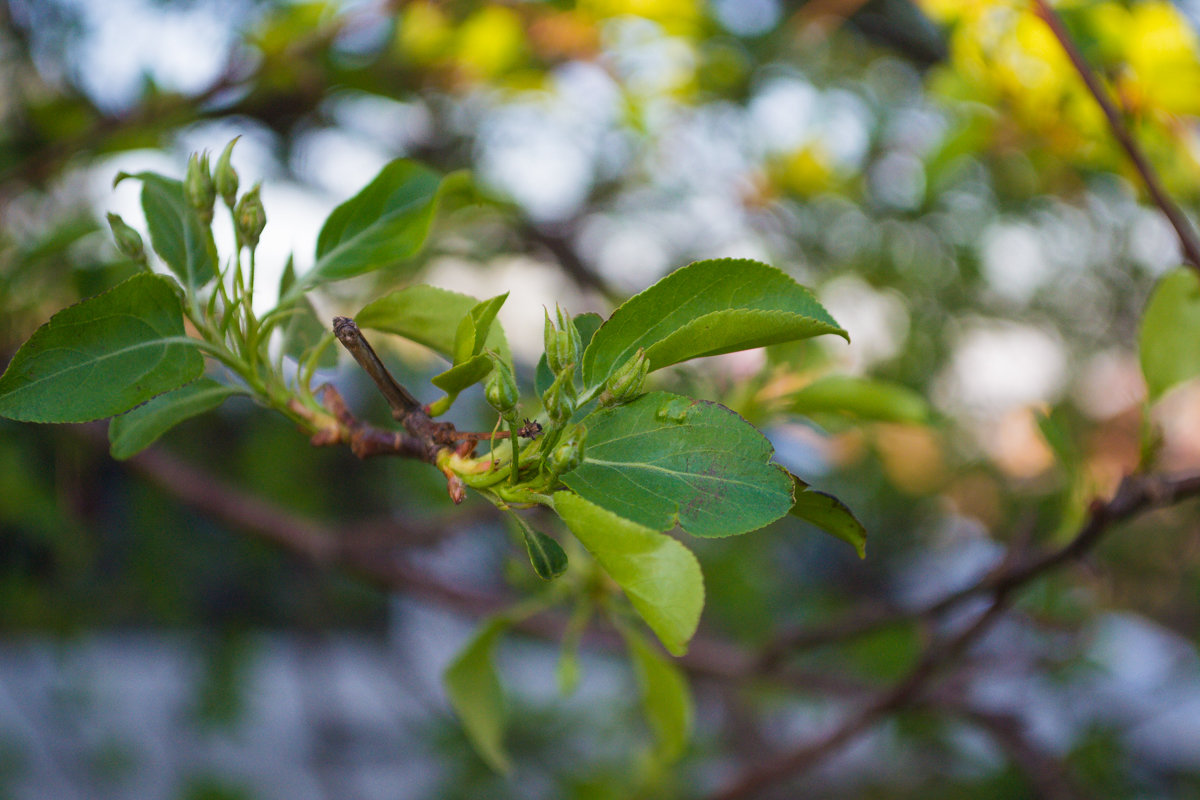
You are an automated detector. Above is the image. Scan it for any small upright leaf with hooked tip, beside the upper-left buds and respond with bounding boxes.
[118,173,217,289]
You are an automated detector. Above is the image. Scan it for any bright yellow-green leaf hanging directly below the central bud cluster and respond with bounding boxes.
[553,492,704,656]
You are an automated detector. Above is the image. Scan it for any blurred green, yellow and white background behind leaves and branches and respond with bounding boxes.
[0,0,1200,799]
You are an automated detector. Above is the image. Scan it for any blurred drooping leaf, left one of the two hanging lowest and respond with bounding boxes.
[442,618,511,772]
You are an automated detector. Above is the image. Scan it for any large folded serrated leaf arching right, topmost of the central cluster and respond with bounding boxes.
[583,259,850,386]
